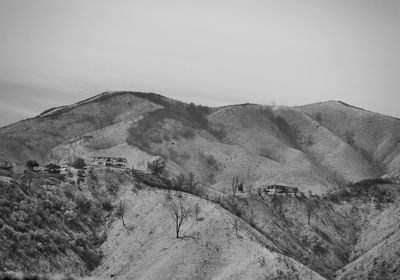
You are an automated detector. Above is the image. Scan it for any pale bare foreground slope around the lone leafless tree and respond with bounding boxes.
[84,188,324,279]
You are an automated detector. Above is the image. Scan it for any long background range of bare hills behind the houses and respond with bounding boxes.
[0,92,400,193]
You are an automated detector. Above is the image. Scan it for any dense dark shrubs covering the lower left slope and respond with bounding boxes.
[0,176,108,272]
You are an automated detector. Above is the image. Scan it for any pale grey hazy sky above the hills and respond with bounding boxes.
[0,0,400,126]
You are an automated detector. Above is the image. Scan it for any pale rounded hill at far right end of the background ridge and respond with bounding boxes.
[300,101,400,175]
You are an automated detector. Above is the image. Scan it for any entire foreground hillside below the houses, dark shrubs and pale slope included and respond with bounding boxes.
[0,161,400,280]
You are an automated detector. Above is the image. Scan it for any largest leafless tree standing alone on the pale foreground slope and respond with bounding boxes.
[166,194,191,238]
